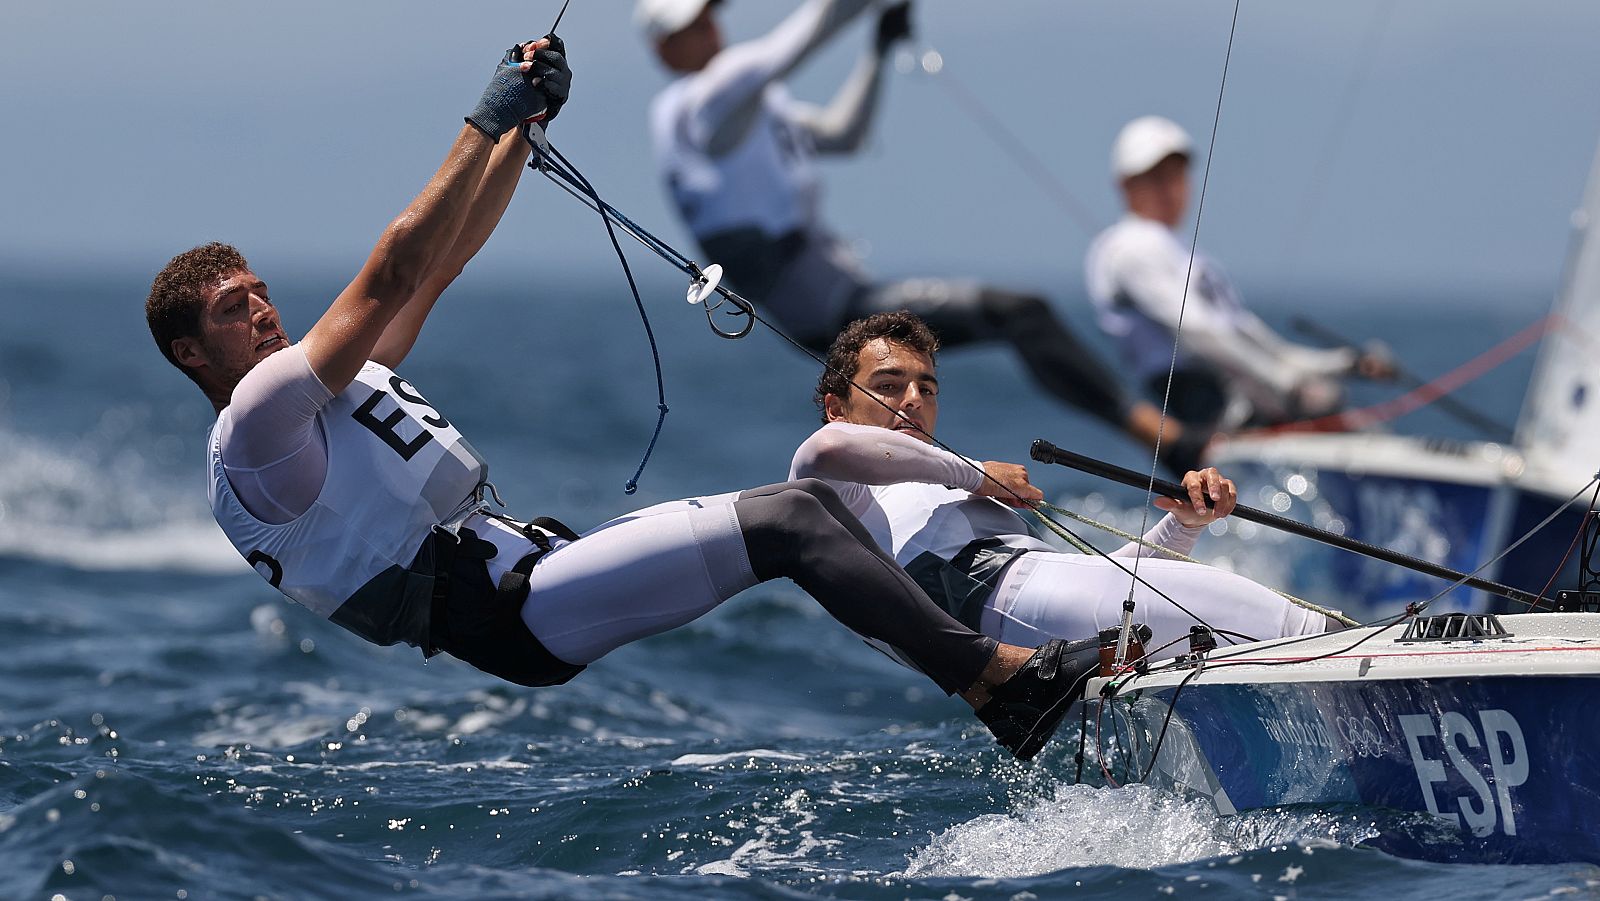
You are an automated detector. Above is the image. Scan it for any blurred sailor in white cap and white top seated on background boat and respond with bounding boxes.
[1085,115,1395,430]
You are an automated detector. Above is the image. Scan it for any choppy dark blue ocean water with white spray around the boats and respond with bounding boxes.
[0,264,1600,901]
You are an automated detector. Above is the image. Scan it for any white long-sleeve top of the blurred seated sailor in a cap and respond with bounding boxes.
[1085,213,1357,418]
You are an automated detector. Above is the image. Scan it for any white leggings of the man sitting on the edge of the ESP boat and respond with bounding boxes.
[981,551,1326,659]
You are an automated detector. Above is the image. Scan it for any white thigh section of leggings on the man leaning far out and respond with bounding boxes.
[469,493,755,664]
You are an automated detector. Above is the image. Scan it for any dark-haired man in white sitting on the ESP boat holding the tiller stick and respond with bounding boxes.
[789,312,1330,656]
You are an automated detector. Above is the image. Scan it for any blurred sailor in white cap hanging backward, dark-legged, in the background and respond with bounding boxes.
[635,0,1205,472]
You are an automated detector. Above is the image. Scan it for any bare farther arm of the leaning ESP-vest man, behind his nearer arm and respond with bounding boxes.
[370,131,530,368]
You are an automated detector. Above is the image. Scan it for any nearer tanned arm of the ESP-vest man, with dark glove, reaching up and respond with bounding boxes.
[301,39,565,394]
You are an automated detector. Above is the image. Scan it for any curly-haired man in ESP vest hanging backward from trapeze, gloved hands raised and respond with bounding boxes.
[146,40,1093,757]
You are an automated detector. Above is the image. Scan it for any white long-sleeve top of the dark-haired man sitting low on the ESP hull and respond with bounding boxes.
[789,422,1202,567]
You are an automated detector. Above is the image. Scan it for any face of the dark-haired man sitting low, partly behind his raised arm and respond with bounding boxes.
[826,338,939,443]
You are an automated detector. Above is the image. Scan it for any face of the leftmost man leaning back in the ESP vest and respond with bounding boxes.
[173,269,290,387]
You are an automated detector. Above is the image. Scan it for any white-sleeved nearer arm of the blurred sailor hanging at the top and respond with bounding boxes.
[688,0,870,157]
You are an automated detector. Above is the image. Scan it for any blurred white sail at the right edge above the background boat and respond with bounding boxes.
[1517,140,1600,491]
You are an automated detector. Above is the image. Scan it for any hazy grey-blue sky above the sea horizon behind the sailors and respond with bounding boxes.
[0,0,1600,304]
